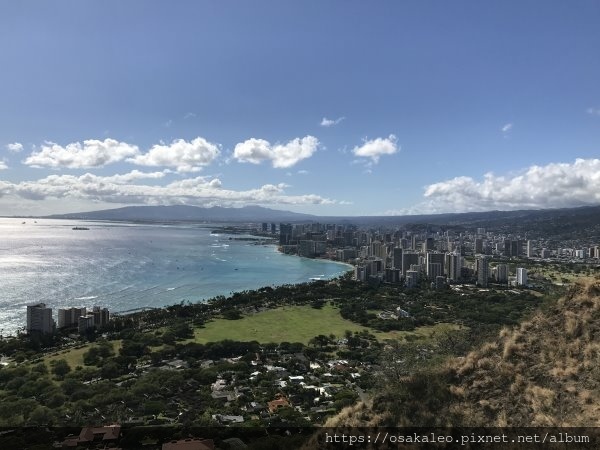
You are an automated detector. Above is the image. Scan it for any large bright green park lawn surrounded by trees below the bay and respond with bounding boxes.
[194,304,459,344]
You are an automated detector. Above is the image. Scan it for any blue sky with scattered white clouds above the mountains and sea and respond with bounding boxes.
[0,0,600,216]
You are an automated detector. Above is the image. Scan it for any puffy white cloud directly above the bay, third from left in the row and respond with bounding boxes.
[233,136,319,169]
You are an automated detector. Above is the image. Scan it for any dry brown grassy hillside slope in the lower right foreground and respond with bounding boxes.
[327,280,600,427]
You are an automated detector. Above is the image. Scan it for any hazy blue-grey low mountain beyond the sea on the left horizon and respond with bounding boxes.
[48,205,318,222]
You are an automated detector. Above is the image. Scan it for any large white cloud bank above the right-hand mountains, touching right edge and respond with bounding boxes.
[415,159,600,212]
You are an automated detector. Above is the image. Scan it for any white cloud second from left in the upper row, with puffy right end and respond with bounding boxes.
[127,137,221,172]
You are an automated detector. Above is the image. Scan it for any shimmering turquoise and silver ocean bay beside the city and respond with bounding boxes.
[0,218,348,335]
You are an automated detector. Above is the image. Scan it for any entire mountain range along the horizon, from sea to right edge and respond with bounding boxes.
[48,205,600,240]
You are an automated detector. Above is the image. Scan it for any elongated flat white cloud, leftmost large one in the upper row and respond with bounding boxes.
[23,139,139,169]
